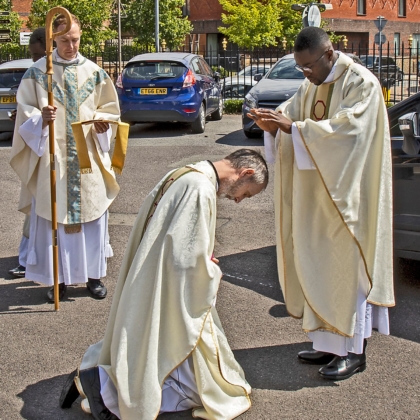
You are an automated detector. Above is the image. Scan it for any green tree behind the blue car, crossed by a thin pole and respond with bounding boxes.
[112,0,192,49]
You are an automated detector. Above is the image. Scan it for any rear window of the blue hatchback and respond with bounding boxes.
[123,60,187,80]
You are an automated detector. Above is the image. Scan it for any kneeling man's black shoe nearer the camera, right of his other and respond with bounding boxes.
[79,366,118,420]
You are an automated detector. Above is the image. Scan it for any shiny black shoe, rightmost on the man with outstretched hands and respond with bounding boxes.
[319,353,366,381]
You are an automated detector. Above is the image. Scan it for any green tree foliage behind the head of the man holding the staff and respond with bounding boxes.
[28,0,116,52]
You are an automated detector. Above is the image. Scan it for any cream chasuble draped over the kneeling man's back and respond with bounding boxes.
[80,162,251,420]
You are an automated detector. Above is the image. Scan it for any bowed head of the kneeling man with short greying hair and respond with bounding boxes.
[214,149,268,203]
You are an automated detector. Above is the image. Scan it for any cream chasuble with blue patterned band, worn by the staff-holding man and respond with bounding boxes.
[10,55,120,226]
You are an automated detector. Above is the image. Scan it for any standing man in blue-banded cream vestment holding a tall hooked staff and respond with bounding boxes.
[10,16,120,301]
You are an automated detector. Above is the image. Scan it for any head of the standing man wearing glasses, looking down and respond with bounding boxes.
[294,26,338,85]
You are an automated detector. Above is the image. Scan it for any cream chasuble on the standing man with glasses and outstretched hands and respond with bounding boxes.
[275,54,394,337]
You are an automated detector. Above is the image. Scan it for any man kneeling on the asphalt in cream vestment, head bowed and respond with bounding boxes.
[60,149,268,420]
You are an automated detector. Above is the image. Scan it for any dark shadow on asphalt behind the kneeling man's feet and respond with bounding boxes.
[17,375,92,420]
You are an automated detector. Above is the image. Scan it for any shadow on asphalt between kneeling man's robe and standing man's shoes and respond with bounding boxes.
[233,342,338,391]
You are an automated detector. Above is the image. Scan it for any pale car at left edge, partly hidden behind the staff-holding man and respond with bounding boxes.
[0,58,34,131]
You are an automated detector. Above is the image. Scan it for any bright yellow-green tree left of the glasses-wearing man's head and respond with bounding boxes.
[218,0,314,49]
